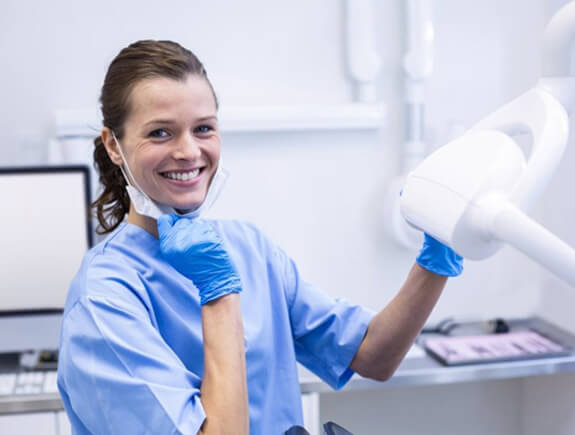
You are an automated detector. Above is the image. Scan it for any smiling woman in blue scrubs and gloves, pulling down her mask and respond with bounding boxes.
[58,41,462,435]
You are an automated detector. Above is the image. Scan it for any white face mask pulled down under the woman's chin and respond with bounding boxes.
[112,132,229,219]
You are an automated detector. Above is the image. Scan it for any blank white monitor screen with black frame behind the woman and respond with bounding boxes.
[0,166,92,315]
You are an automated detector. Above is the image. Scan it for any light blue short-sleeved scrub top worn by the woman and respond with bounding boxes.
[58,221,373,435]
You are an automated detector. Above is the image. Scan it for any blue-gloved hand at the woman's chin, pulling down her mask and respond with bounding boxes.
[158,214,242,305]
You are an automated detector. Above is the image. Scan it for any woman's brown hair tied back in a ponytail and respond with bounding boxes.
[91,40,218,234]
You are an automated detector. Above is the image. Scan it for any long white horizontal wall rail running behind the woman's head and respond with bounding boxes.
[55,103,386,138]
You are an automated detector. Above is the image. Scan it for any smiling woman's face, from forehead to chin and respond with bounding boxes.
[112,75,221,215]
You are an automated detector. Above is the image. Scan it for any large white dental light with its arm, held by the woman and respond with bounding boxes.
[400,2,575,286]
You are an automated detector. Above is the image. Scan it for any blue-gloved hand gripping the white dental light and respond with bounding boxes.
[416,233,463,276]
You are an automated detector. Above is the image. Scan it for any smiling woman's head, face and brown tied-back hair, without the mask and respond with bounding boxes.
[92,41,220,234]
